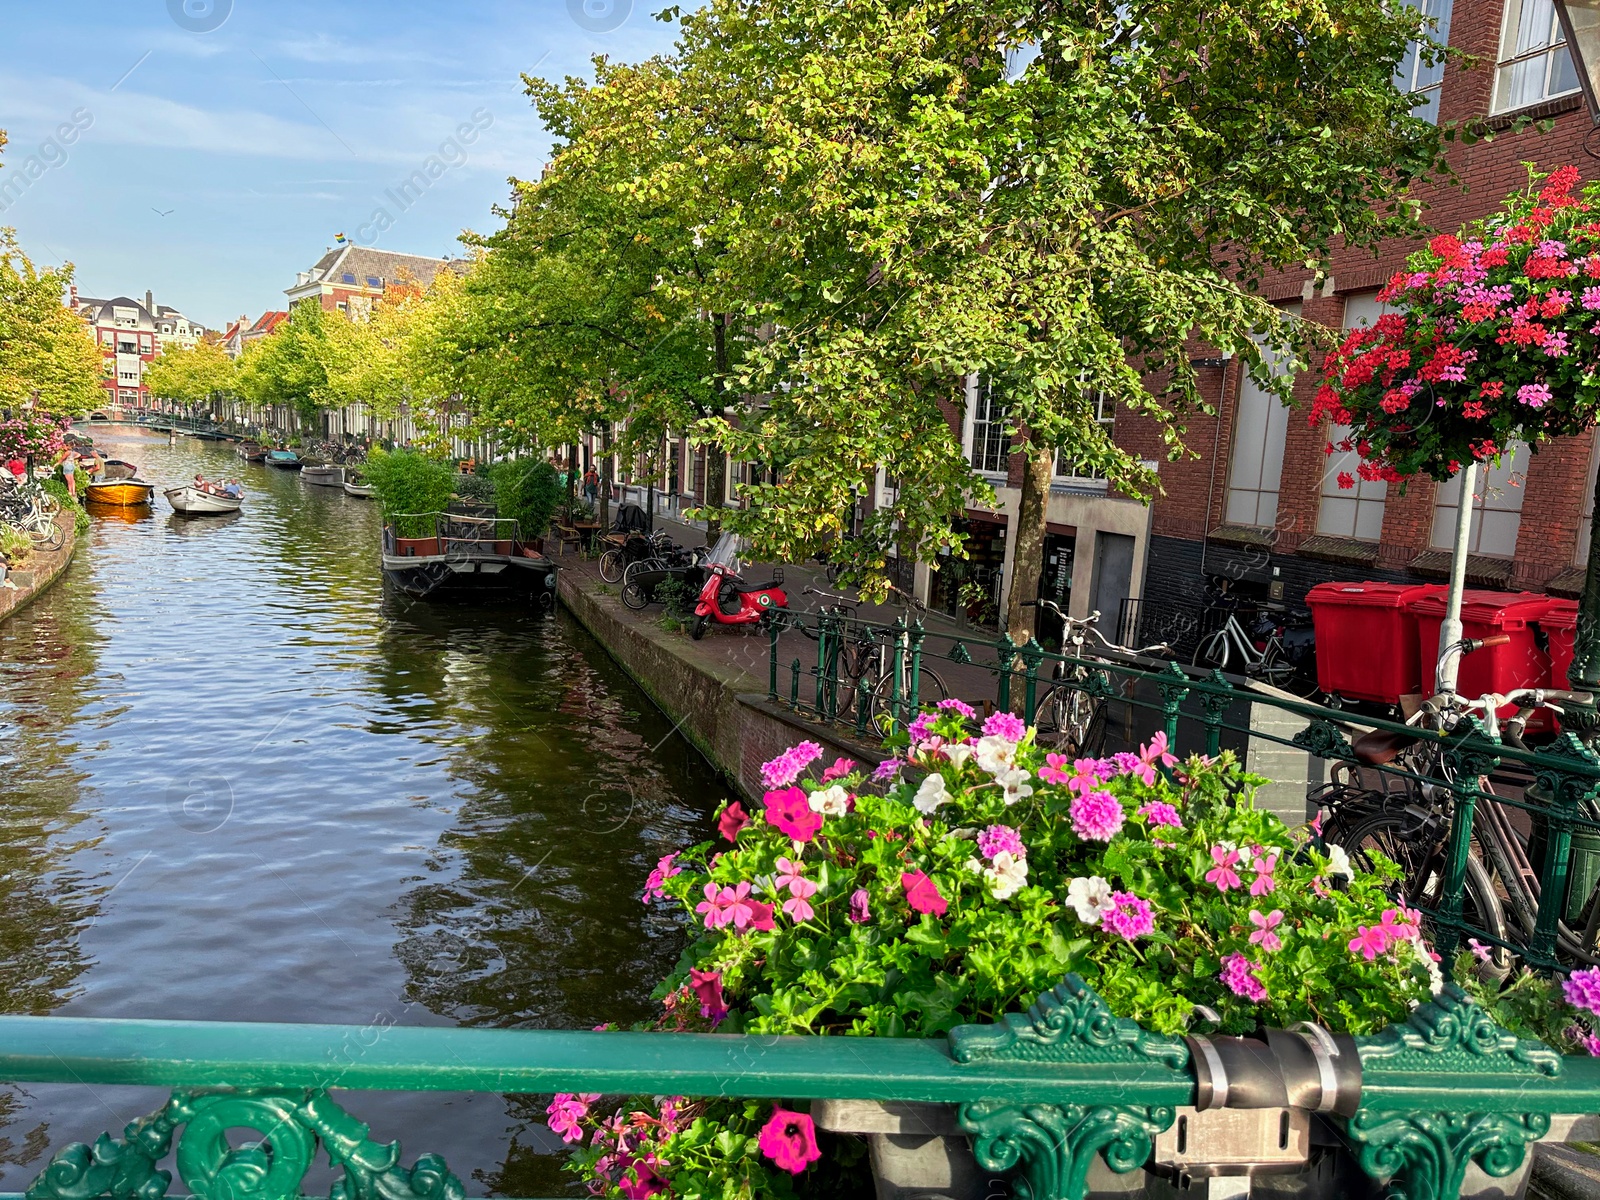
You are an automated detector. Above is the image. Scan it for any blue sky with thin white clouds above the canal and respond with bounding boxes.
[0,0,674,326]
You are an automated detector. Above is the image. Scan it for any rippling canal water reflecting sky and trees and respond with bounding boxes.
[0,429,730,1195]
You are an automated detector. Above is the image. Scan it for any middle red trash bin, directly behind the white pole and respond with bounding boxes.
[1411,589,1555,699]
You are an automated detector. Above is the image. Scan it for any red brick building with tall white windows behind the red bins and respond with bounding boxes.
[1117,0,1600,633]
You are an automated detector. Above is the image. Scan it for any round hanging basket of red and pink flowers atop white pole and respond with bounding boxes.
[1310,166,1600,486]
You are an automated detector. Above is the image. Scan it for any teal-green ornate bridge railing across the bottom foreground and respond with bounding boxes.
[9,976,1600,1200]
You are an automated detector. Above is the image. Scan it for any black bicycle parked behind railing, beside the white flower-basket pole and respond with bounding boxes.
[1312,635,1600,970]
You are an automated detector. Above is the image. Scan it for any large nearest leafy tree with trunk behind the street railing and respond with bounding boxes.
[643,0,1442,632]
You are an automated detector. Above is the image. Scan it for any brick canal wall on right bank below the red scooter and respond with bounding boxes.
[558,570,883,802]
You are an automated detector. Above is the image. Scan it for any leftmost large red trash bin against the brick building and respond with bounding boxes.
[1306,582,1445,704]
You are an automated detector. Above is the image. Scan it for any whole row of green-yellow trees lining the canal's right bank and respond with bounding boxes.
[87,0,1456,629]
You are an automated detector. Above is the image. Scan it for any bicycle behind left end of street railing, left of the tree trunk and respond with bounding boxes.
[800,586,950,728]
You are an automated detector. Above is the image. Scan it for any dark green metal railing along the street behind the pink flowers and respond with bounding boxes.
[768,614,1600,970]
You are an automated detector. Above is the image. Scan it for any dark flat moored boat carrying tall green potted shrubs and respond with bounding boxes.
[382,512,555,613]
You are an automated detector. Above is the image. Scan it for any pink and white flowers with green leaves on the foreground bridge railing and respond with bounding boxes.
[550,710,1442,1197]
